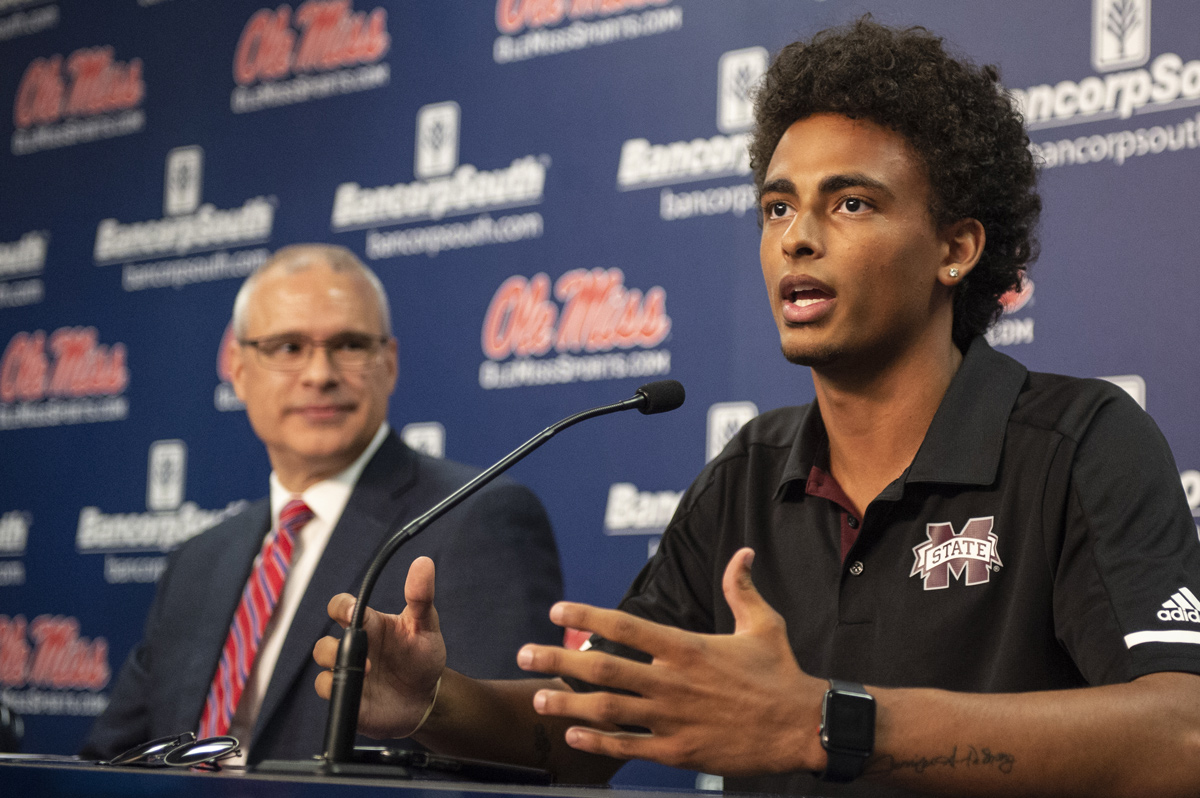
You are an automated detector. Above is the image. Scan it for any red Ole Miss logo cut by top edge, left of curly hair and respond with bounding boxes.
[492,0,683,64]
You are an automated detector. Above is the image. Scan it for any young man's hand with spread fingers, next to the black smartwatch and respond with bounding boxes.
[517,548,826,775]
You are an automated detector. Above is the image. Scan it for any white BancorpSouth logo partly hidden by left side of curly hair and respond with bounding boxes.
[617,47,767,221]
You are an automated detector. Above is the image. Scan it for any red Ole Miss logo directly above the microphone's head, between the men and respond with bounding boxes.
[479,268,671,389]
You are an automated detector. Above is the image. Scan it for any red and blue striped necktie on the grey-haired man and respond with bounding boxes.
[200,499,313,738]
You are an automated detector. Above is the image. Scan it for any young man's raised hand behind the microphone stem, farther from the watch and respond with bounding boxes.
[312,557,446,738]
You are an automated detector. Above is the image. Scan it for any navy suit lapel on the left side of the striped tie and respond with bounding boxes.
[174,499,271,730]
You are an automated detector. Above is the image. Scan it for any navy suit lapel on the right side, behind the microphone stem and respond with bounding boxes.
[252,432,416,745]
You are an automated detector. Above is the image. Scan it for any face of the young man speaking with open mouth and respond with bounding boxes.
[760,114,950,371]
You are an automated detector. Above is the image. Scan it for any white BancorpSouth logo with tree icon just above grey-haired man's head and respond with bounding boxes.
[331,101,550,235]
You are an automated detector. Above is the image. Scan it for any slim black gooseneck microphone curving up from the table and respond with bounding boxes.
[323,379,684,772]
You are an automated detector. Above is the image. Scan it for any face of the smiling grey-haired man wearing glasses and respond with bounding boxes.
[229,262,396,491]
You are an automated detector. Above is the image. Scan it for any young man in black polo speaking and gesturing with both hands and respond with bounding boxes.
[316,20,1200,796]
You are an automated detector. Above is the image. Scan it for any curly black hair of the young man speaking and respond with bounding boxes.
[750,14,1042,350]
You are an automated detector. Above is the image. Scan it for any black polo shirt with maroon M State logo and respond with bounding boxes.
[580,338,1200,794]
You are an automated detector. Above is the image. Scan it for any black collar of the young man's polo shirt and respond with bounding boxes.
[775,336,1028,497]
